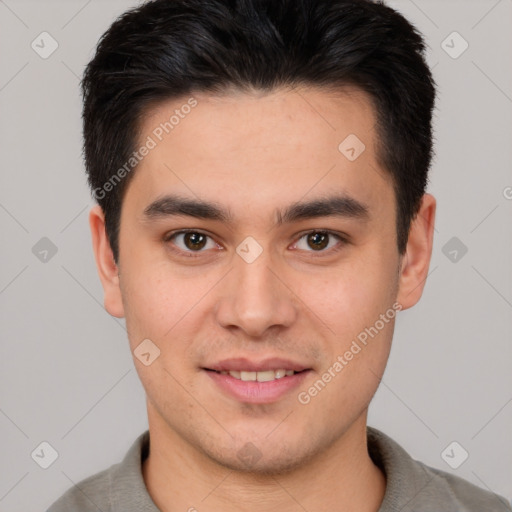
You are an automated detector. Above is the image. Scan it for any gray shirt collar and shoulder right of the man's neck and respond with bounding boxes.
[367,427,512,512]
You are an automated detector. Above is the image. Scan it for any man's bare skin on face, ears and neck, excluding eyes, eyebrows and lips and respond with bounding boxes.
[90,88,436,512]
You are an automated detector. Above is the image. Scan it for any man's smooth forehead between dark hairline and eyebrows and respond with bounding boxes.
[126,88,394,225]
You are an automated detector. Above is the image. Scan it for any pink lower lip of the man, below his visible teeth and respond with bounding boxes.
[205,370,311,404]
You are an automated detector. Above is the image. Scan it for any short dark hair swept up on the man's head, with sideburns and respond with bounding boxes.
[81,0,435,261]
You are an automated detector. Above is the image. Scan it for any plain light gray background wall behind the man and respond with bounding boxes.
[0,0,512,512]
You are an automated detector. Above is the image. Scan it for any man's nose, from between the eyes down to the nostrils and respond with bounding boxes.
[216,244,299,338]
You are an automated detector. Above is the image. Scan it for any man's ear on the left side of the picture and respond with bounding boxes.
[89,205,124,318]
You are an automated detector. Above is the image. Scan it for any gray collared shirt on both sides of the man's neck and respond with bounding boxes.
[47,427,512,512]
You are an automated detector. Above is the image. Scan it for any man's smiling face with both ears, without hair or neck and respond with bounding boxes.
[91,89,433,473]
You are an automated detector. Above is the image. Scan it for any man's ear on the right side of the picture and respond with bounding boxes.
[397,194,436,309]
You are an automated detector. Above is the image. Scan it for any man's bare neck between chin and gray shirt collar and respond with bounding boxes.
[142,407,386,512]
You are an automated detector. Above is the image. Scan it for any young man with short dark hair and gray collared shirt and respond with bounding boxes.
[49,0,510,512]
